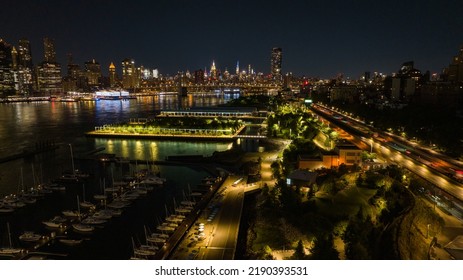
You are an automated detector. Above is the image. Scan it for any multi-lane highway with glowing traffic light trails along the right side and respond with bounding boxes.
[311,105,463,202]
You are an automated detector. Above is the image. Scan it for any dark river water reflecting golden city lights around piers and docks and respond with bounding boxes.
[0,93,236,259]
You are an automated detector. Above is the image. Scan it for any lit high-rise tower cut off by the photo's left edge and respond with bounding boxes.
[0,39,15,95]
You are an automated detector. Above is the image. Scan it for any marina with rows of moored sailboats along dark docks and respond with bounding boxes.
[0,152,227,259]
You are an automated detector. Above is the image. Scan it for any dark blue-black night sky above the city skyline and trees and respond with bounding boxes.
[0,0,463,79]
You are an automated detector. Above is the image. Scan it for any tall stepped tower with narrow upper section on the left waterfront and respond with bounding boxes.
[37,38,63,95]
